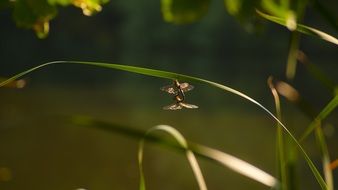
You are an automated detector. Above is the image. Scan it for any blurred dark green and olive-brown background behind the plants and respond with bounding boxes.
[0,0,338,190]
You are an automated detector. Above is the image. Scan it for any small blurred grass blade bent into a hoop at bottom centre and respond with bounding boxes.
[138,125,207,190]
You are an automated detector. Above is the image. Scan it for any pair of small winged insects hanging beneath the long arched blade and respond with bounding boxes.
[161,80,198,110]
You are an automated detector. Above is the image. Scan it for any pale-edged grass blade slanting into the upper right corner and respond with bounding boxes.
[256,10,338,45]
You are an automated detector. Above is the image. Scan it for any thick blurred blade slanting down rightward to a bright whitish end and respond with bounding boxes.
[71,116,279,187]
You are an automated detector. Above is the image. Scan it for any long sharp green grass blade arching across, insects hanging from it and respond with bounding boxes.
[0,61,327,189]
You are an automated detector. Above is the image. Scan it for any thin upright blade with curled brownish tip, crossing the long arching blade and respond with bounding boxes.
[267,76,288,190]
